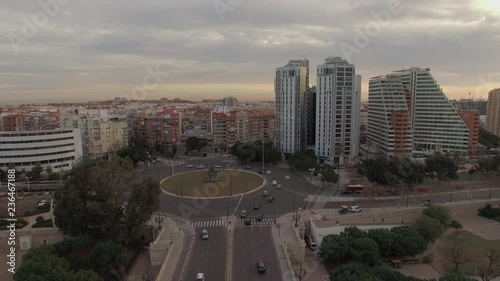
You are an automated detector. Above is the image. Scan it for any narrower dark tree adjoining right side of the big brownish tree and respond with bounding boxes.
[124,177,161,243]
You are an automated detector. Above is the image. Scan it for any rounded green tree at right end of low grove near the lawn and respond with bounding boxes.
[391,226,427,256]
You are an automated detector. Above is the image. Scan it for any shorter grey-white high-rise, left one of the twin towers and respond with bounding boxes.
[274,60,309,154]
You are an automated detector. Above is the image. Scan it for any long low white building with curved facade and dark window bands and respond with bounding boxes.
[0,129,83,172]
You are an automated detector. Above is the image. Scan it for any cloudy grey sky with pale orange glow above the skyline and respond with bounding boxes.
[0,0,500,105]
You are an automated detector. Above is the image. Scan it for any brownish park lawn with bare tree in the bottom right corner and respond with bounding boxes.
[436,230,500,275]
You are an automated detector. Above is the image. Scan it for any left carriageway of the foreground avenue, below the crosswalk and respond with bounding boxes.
[184,227,227,280]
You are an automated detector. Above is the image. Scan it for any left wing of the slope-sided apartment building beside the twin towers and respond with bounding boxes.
[367,75,413,157]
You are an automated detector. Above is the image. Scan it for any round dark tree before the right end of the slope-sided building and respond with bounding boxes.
[425,153,458,181]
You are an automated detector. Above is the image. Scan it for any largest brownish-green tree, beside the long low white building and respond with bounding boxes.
[54,157,134,240]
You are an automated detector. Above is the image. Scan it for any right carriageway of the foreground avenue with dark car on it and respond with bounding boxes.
[233,226,282,281]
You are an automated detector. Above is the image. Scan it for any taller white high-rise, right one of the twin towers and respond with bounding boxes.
[315,57,361,165]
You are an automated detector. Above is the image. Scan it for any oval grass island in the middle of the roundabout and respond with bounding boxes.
[161,170,262,197]
